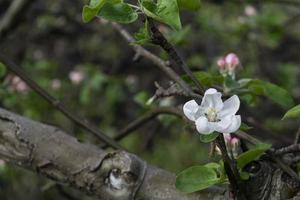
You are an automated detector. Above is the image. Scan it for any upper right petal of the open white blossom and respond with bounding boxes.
[218,95,240,118]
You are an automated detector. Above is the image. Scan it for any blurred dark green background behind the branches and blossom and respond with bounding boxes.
[0,0,300,200]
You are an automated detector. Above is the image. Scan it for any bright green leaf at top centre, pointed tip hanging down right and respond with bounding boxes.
[141,0,181,30]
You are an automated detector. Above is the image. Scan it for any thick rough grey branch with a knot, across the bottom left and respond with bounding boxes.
[0,108,225,200]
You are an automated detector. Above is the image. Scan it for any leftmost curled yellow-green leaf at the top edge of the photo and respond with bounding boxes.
[82,0,123,23]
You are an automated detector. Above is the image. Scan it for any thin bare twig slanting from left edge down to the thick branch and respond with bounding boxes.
[0,53,124,149]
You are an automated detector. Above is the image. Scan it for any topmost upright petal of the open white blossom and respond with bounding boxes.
[201,88,223,112]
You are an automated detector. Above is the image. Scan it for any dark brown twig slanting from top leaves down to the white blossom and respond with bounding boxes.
[148,18,204,94]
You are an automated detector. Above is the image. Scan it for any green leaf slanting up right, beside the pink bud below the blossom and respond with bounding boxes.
[237,143,272,169]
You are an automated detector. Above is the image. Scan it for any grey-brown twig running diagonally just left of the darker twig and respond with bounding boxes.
[111,23,202,98]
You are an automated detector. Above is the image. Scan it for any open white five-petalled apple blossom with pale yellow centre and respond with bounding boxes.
[183,88,241,134]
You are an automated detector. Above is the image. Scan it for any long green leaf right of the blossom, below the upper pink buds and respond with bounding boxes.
[247,80,294,107]
